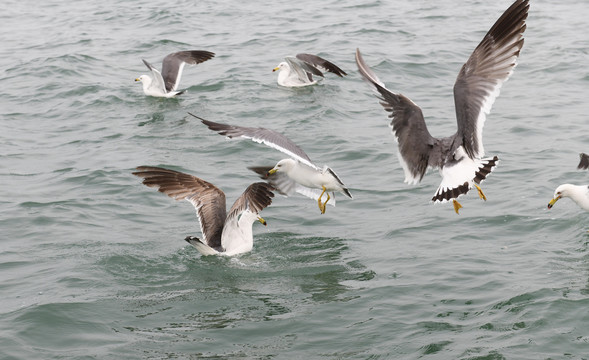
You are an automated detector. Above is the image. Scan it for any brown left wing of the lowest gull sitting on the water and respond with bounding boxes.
[133,166,226,248]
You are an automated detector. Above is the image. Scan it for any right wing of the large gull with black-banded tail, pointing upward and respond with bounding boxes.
[454,0,529,159]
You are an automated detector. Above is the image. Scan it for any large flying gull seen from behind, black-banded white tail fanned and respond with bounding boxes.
[356,0,529,214]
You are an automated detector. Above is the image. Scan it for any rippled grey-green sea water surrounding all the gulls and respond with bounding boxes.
[0,0,589,359]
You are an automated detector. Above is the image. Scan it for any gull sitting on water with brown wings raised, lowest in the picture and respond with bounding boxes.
[133,166,274,256]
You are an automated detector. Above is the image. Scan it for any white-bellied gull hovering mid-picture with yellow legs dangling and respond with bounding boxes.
[189,113,352,214]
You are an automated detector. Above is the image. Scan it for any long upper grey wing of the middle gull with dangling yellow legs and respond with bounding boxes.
[188,113,319,169]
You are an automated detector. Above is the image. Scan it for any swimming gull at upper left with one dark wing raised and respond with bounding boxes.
[135,50,215,97]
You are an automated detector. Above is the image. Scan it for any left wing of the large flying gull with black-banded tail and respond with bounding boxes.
[356,49,435,184]
